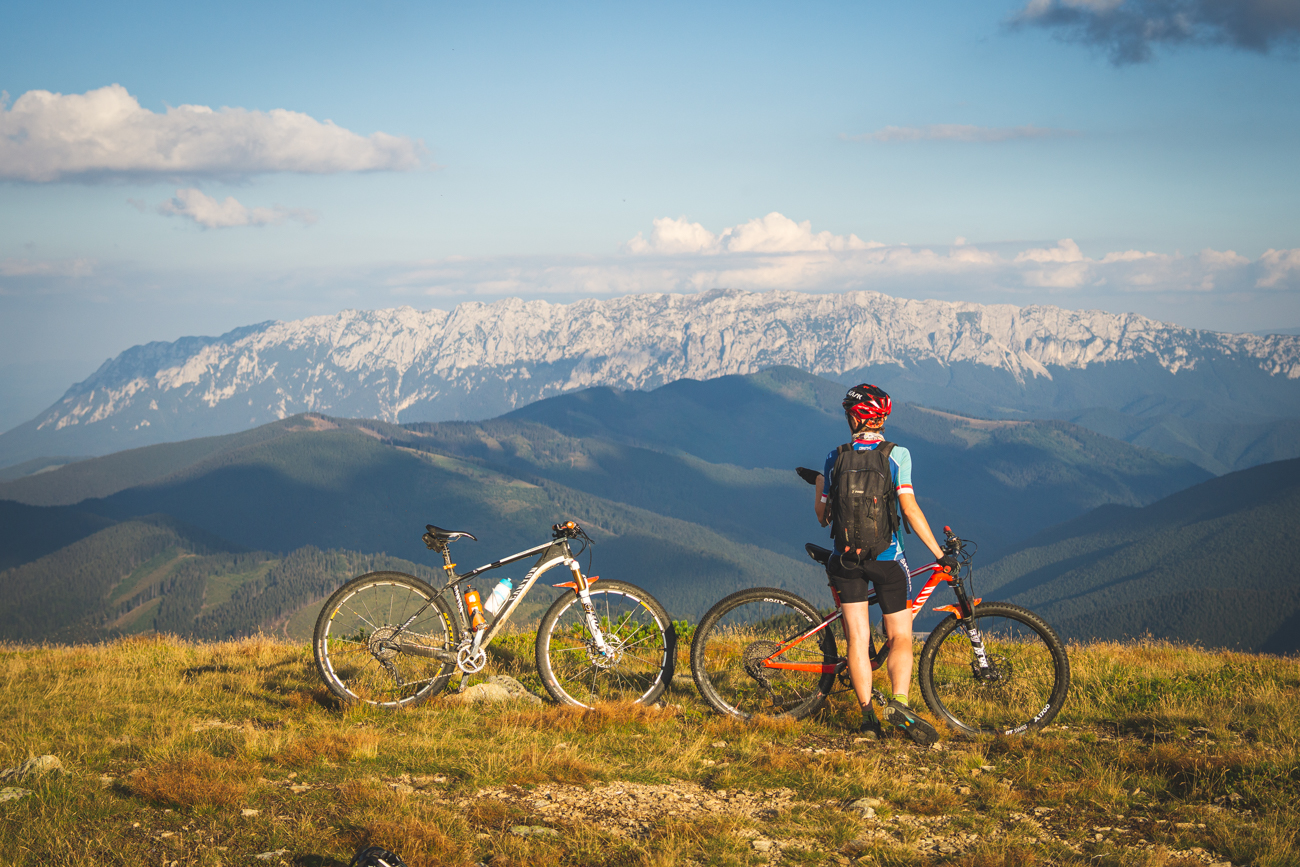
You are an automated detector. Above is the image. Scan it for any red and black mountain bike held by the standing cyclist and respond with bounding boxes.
[690,467,1070,734]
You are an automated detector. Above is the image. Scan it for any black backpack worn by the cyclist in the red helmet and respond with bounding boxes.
[827,442,898,560]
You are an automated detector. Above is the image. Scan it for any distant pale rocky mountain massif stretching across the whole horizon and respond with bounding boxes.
[0,290,1300,464]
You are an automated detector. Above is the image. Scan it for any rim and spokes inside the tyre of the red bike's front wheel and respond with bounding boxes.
[931,615,1057,734]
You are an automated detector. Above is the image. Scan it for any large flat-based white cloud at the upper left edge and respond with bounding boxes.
[0,84,424,182]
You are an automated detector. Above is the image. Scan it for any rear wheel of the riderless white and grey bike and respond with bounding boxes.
[313,572,460,707]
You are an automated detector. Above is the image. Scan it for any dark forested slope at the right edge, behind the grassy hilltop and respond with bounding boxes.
[978,460,1300,653]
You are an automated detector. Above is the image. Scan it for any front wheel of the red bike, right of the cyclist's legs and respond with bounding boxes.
[917,602,1070,734]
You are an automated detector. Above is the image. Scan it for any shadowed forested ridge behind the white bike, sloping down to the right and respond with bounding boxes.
[50,429,815,615]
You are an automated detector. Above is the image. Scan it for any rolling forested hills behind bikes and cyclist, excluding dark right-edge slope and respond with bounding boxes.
[0,368,1227,638]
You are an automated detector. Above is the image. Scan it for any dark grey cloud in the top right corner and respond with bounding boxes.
[1011,0,1300,65]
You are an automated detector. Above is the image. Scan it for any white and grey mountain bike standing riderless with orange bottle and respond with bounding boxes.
[313,521,677,707]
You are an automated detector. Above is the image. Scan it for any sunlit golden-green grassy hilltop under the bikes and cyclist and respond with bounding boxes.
[0,633,1300,867]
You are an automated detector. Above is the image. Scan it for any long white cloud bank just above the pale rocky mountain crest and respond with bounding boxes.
[385,212,1300,308]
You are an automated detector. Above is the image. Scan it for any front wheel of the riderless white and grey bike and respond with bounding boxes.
[537,578,677,707]
